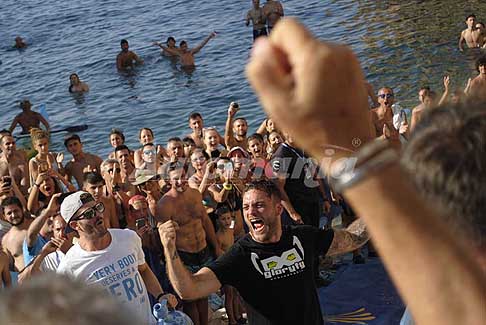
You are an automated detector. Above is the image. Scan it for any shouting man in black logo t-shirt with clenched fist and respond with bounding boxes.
[159,180,368,324]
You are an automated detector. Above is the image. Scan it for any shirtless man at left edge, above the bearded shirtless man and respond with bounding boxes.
[0,135,29,195]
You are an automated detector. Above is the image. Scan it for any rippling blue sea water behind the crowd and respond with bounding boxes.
[0,0,486,157]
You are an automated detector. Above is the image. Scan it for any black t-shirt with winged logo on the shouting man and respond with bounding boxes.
[205,226,334,325]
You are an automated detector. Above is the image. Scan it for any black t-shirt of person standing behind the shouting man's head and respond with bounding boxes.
[271,143,320,207]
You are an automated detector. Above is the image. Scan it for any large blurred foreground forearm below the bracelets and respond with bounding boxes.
[344,165,486,324]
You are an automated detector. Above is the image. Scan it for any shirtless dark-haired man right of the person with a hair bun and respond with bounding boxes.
[59,134,103,188]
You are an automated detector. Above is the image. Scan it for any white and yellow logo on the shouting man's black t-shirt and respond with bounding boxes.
[251,236,305,280]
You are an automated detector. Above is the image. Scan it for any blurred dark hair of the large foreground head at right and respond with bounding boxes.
[401,101,486,245]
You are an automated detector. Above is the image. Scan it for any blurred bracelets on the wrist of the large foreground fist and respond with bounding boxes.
[331,141,398,193]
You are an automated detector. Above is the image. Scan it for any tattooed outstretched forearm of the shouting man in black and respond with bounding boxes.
[326,218,370,256]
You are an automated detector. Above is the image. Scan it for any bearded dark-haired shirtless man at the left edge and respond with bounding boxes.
[2,196,32,272]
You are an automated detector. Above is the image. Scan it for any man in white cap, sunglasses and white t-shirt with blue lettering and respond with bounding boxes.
[57,191,175,324]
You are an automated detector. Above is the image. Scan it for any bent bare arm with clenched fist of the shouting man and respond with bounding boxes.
[158,220,221,300]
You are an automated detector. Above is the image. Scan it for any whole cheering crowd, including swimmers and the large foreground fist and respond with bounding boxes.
[0,0,486,324]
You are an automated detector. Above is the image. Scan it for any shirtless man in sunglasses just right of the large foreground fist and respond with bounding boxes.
[370,87,400,145]
